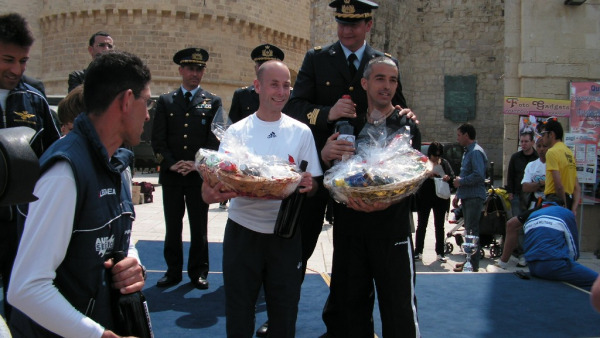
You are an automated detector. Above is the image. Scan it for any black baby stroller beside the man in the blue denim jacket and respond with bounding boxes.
[444,163,511,258]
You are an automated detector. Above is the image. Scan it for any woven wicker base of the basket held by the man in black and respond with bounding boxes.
[325,171,427,204]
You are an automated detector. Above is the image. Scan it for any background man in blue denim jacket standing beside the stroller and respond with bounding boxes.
[452,123,488,272]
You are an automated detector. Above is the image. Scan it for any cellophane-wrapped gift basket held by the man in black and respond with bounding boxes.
[323,122,427,204]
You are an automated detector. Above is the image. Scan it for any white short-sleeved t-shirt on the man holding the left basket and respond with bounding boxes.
[219,113,323,234]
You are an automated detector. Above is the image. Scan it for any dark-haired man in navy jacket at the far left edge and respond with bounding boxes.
[0,13,60,317]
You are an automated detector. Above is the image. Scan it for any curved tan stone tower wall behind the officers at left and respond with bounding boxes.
[34,0,310,108]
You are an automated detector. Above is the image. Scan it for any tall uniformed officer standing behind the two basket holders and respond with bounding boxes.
[284,0,420,334]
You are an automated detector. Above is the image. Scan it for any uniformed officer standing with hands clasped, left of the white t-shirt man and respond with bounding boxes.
[152,48,222,289]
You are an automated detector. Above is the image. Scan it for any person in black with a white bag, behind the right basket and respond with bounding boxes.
[415,141,454,262]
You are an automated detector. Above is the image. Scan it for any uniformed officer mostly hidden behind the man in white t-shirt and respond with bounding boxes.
[229,43,285,123]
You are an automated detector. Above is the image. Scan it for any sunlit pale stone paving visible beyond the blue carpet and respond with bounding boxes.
[133,173,600,273]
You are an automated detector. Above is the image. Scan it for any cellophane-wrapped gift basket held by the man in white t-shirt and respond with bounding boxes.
[195,119,302,199]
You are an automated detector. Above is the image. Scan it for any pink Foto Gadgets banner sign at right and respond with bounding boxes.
[504,96,571,117]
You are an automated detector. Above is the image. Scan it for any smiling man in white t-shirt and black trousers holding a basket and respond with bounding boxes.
[202,61,323,337]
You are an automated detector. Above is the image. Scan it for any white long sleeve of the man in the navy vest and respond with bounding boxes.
[8,161,139,337]
